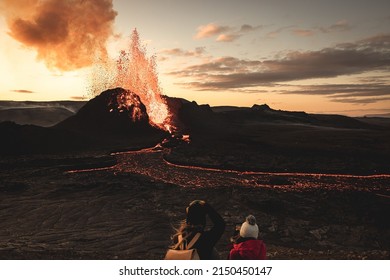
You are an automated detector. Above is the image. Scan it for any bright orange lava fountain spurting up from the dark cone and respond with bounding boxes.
[92,29,175,133]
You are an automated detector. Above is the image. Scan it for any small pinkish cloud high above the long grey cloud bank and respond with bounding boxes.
[194,23,262,42]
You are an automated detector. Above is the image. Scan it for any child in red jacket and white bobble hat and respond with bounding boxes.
[228,215,266,260]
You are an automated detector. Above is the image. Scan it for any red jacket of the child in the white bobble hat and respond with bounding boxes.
[229,239,266,260]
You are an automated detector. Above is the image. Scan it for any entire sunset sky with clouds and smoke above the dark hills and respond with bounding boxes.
[0,0,390,116]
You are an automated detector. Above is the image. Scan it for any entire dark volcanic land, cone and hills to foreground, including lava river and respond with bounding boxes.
[0,89,390,259]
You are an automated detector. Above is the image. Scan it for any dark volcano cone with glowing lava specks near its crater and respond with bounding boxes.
[0,88,167,154]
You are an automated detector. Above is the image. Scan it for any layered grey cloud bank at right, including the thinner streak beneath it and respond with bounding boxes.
[170,34,390,103]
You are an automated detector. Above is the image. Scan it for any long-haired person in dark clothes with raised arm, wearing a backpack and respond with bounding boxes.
[168,200,225,260]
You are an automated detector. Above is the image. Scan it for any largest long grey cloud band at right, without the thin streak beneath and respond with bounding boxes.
[171,35,390,90]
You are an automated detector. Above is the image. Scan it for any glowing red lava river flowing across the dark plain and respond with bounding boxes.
[69,145,390,195]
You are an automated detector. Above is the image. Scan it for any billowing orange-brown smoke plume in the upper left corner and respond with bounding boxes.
[0,0,117,71]
